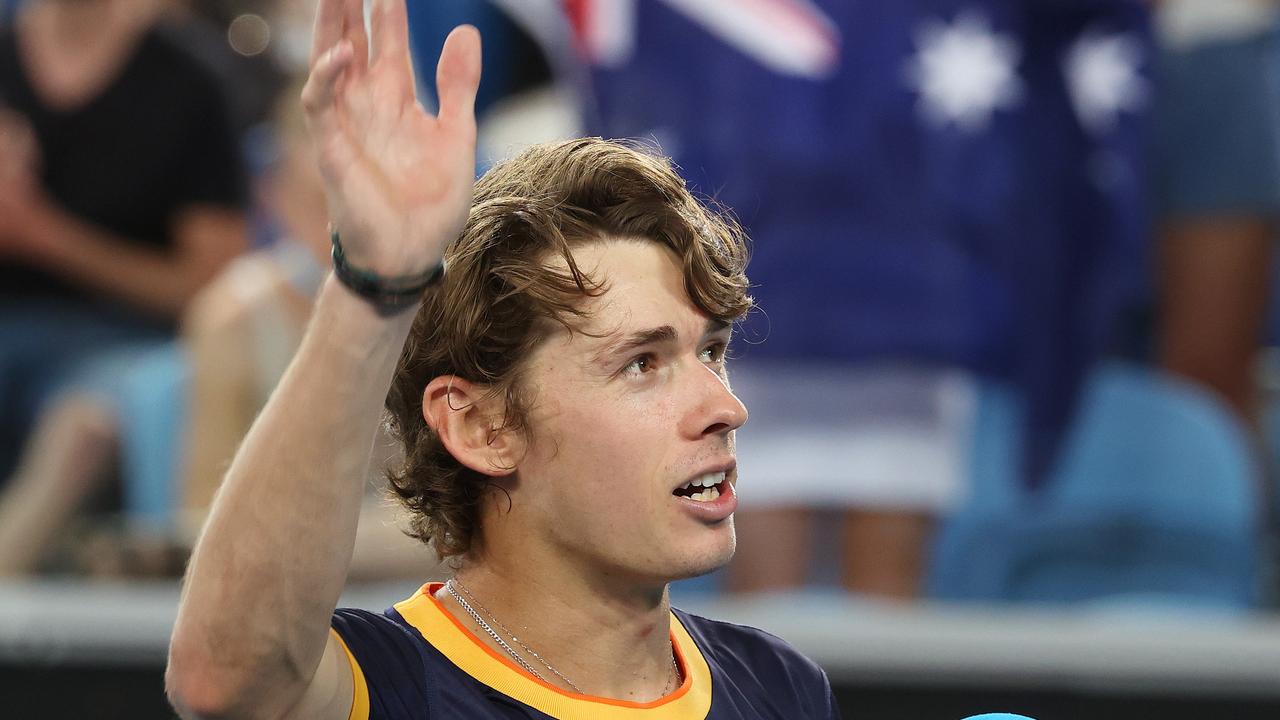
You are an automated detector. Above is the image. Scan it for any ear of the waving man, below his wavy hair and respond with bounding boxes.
[422,375,524,478]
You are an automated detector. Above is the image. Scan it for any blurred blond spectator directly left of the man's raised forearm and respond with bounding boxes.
[182,82,329,528]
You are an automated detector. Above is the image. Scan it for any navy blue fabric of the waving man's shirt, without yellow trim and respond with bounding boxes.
[333,609,840,720]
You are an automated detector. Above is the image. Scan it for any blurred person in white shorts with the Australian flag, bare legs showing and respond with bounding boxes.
[578,0,1148,596]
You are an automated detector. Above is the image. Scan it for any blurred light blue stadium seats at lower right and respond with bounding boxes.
[928,364,1261,609]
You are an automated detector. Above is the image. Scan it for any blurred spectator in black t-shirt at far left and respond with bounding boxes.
[0,0,246,574]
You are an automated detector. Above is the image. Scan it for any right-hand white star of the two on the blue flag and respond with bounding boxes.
[1062,32,1149,135]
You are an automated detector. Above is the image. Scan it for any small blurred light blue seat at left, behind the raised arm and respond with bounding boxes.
[116,342,189,532]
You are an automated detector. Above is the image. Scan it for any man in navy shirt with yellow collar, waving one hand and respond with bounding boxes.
[168,0,837,719]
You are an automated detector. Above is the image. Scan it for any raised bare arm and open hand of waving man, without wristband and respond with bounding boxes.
[165,0,480,707]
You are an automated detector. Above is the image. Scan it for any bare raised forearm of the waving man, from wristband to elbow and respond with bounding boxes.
[170,278,412,717]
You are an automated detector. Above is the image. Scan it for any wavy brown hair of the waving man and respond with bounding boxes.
[387,138,751,557]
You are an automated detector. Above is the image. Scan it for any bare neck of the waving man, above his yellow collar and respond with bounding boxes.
[436,556,673,702]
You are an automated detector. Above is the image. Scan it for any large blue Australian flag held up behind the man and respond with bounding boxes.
[576,0,1151,482]
